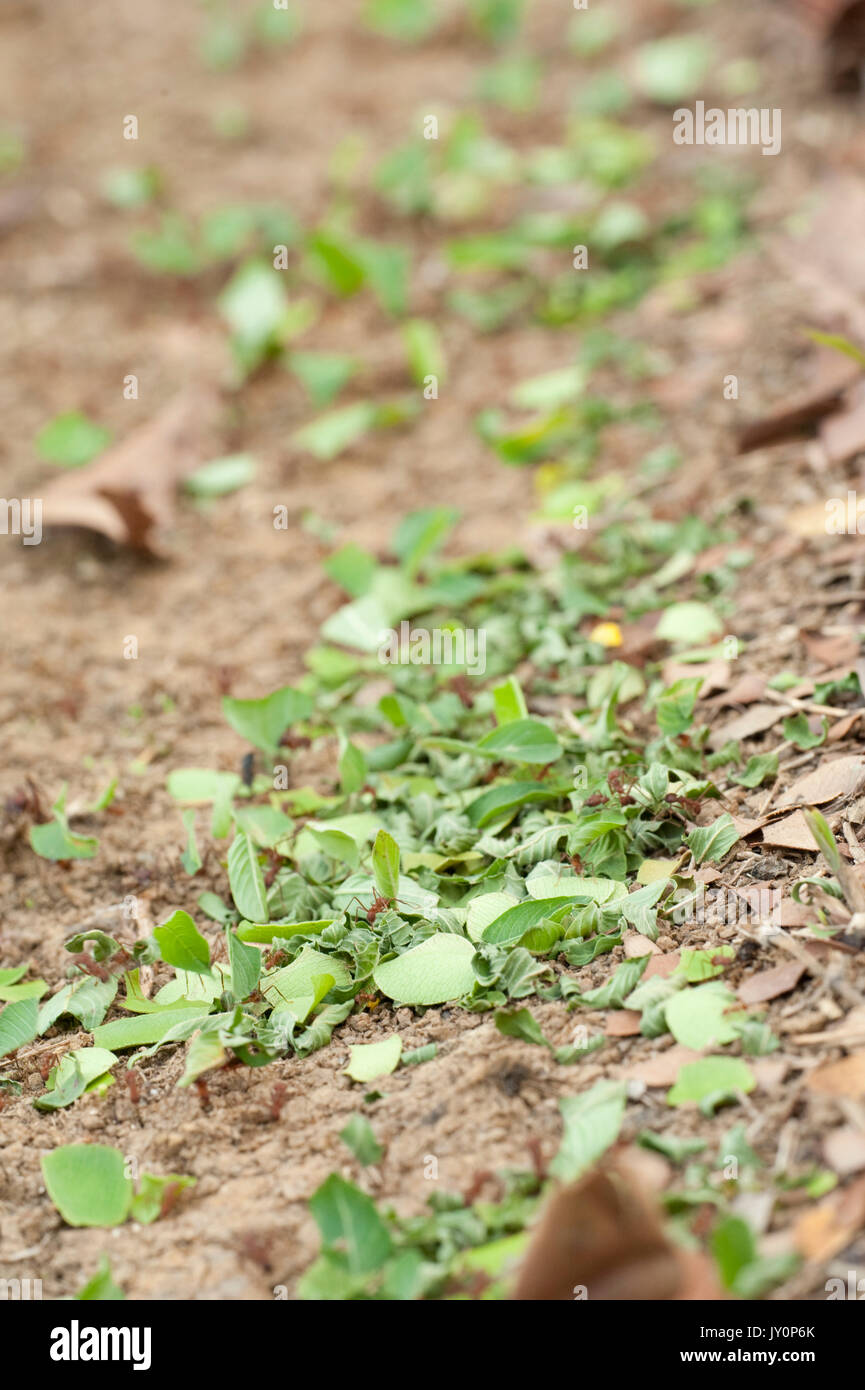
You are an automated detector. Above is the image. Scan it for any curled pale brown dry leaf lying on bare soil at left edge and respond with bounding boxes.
[42,386,218,555]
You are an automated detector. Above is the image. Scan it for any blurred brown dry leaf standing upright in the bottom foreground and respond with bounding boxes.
[513,1155,722,1302]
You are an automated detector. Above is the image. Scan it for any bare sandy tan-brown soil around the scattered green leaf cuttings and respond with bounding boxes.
[0,0,865,1300]
